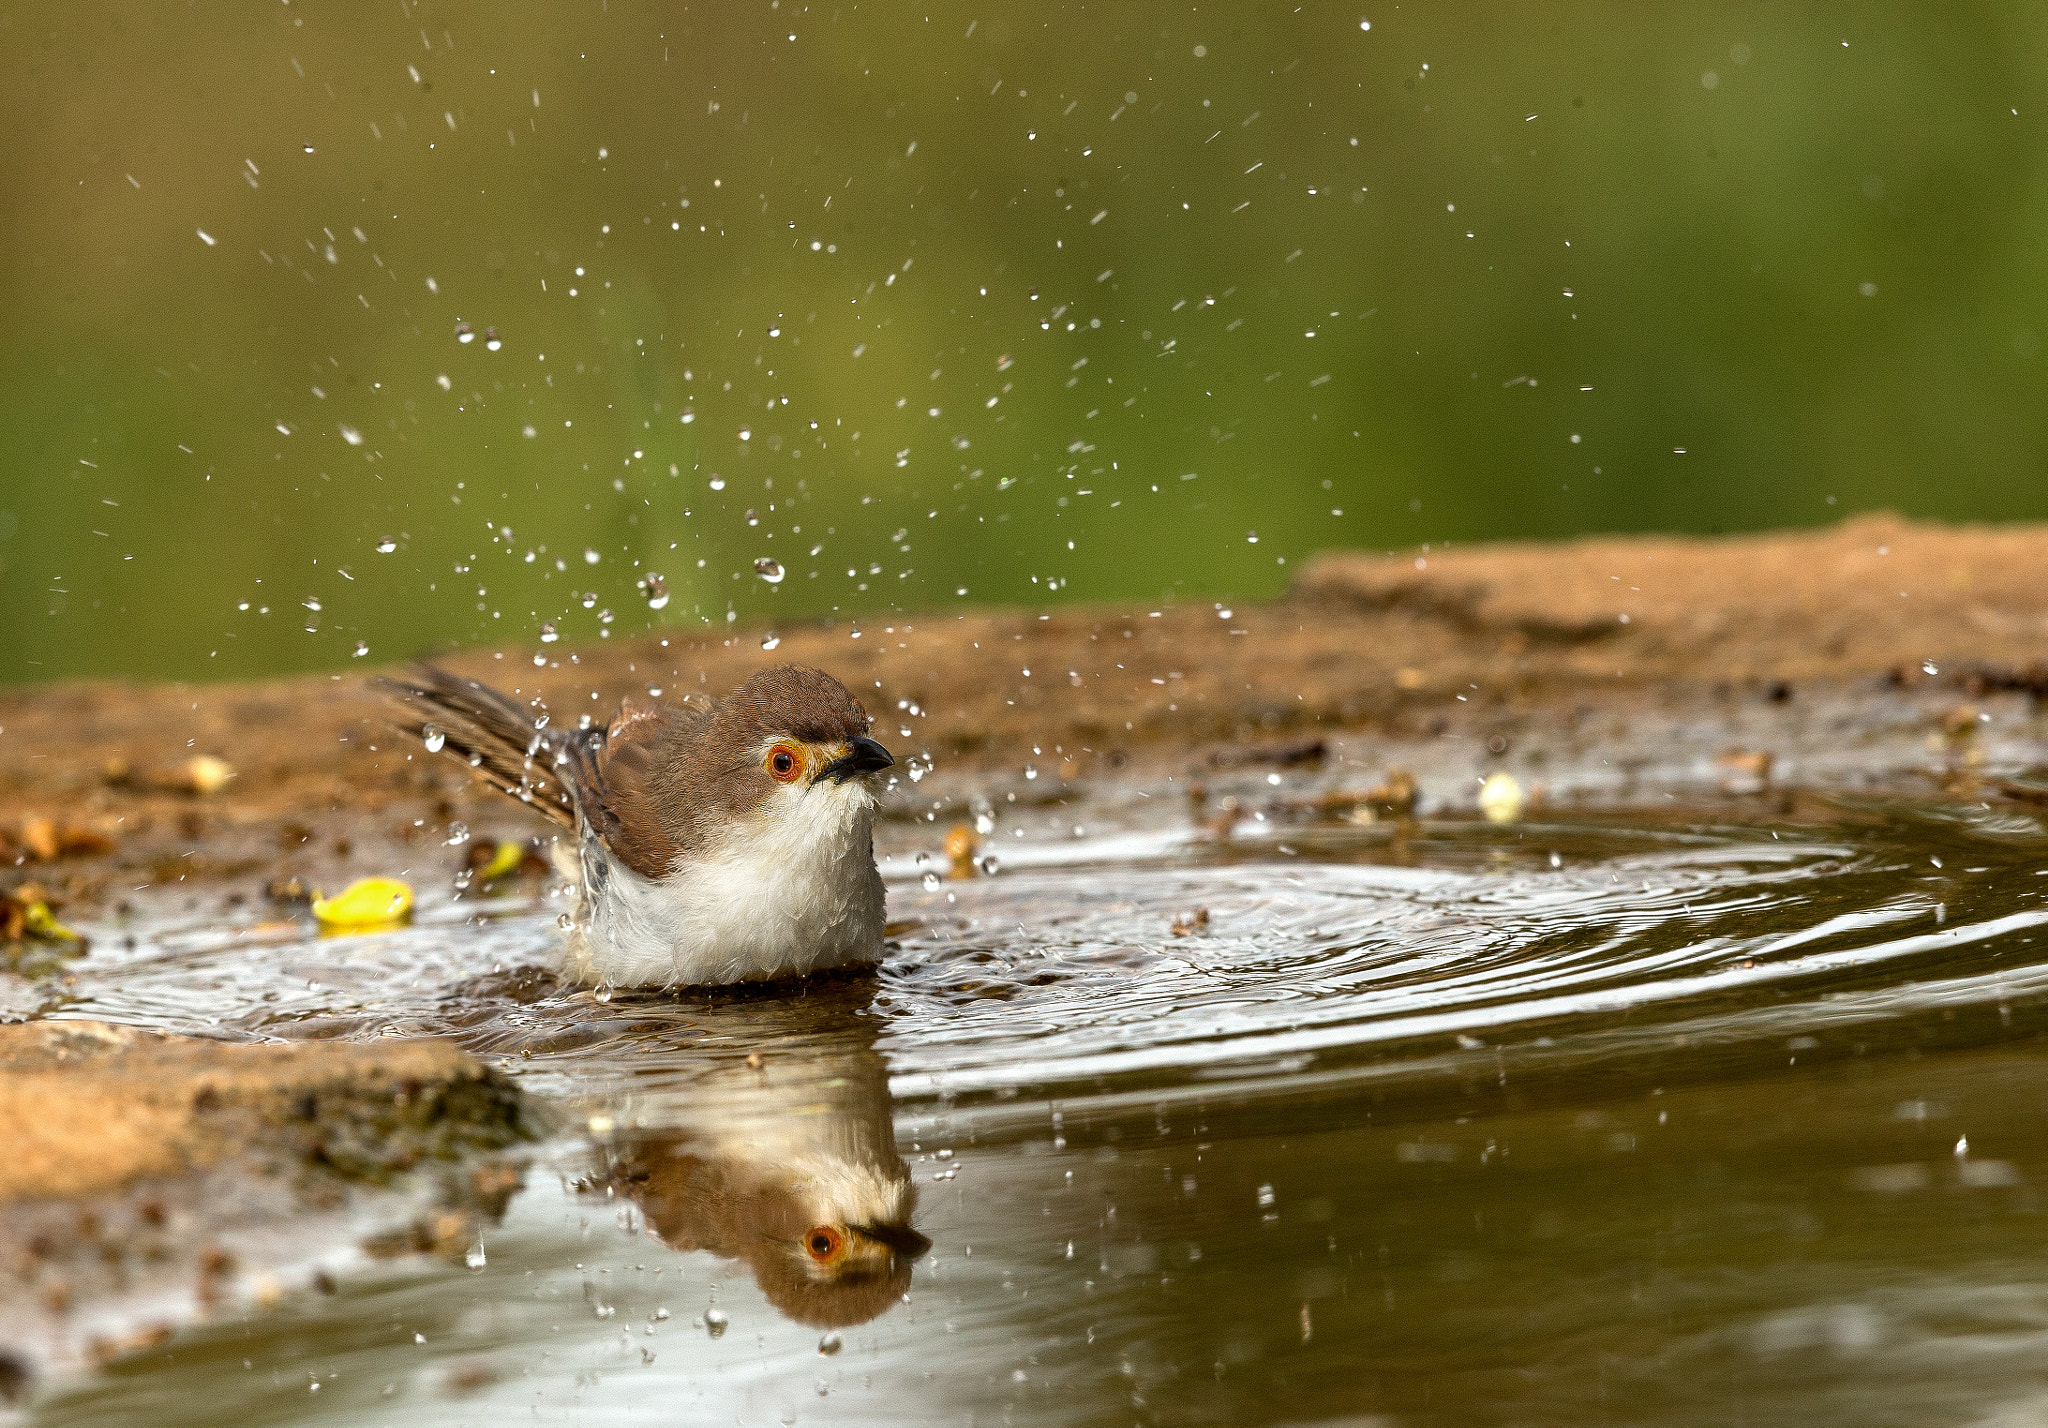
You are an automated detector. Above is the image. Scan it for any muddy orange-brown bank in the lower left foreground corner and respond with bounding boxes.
[0,1020,530,1399]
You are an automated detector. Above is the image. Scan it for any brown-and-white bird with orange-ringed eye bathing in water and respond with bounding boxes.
[377,664,895,988]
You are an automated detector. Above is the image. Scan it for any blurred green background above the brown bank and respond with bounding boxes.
[0,0,2048,680]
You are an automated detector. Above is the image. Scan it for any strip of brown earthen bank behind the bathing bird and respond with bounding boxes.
[0,516,2048,901]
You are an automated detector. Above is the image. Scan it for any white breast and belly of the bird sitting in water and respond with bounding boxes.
[569,779,883,988]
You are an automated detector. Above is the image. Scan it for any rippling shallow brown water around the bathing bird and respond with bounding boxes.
[39,799,2048,1424]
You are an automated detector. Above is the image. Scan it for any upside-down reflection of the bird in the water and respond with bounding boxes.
[586,988,932,1328]
